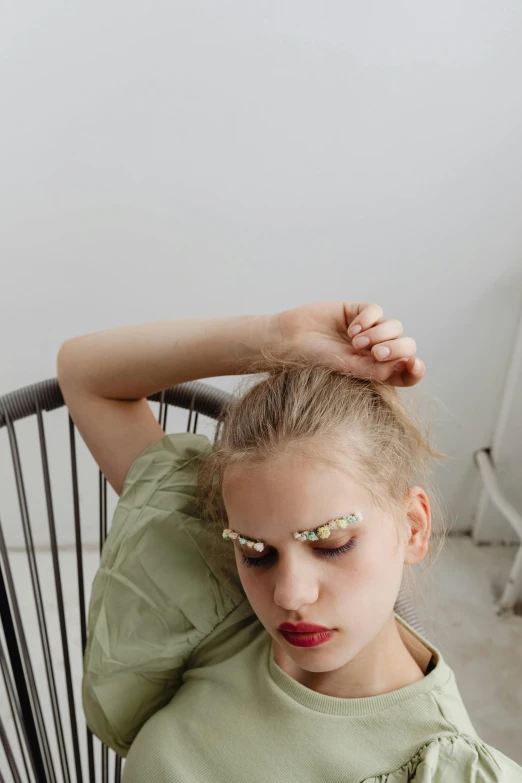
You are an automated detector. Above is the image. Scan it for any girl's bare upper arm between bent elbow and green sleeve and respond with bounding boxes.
[58,350,165,495]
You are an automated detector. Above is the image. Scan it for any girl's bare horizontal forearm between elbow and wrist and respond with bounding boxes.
[57,315,277,400]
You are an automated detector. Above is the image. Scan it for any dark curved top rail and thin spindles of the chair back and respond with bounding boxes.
[0,378,425,783]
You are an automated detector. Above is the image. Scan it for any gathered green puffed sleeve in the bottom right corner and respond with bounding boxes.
[365,734,522,783]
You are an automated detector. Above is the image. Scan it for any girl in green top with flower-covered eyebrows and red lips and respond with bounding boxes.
[58,303,522,783]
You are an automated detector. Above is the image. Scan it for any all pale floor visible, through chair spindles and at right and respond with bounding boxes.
[0,537,522,781]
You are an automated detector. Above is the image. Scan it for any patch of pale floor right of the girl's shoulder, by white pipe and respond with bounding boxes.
[417,536,522,766]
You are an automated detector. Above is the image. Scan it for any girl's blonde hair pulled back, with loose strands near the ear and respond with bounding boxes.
[198,349,447,600]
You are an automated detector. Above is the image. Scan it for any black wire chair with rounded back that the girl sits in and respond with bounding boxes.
[0,378,425,783]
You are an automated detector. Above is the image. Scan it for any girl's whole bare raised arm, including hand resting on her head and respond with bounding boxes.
[57,302,424,495]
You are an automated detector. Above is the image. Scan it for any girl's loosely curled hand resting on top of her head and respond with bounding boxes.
[274,302,425,386]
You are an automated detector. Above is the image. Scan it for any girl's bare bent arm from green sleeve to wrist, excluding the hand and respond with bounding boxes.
[57,315,276,495]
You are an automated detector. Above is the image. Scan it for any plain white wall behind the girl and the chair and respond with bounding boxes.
[0,0,522,545]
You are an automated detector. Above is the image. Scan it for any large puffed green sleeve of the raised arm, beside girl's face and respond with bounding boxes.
[82,433,245,756]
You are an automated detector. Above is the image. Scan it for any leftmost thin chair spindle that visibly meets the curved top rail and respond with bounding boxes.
[1,416,71,783]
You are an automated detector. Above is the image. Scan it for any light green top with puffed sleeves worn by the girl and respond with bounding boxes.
[83,433,522,783]
